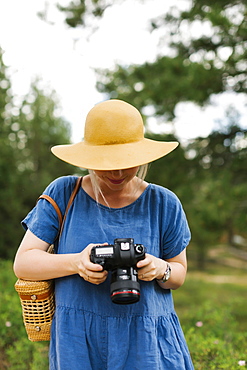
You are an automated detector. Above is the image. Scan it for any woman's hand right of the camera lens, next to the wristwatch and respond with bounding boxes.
[136,253,167,281]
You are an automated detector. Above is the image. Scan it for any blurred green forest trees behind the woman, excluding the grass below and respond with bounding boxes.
[0,0,247,269]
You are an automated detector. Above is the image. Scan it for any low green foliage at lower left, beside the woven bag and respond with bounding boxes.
[0,260,48,370]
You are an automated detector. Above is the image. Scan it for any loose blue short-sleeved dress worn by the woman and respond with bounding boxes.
[22,176,193,370]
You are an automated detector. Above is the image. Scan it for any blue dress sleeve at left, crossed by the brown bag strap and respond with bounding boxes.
[21,176,77,244]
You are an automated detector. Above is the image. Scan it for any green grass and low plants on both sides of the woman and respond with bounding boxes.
[0,260,247,370]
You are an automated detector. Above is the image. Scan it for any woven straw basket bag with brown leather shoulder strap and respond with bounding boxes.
[15,177,82,342]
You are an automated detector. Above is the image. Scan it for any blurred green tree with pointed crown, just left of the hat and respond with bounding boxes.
[15,80,74,196]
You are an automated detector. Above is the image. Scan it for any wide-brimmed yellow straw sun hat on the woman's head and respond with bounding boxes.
[51,99,178,171]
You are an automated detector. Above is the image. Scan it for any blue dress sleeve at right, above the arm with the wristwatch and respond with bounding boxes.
[163,193,191,259]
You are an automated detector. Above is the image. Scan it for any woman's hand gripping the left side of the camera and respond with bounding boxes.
[74,243,108,285]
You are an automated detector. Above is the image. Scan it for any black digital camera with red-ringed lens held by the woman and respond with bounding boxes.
[90,238,145,304]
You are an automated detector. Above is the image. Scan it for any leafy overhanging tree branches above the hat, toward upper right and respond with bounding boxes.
[54,0,247,119]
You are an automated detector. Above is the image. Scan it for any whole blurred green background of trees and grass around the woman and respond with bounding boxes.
[0,0,247,370]
